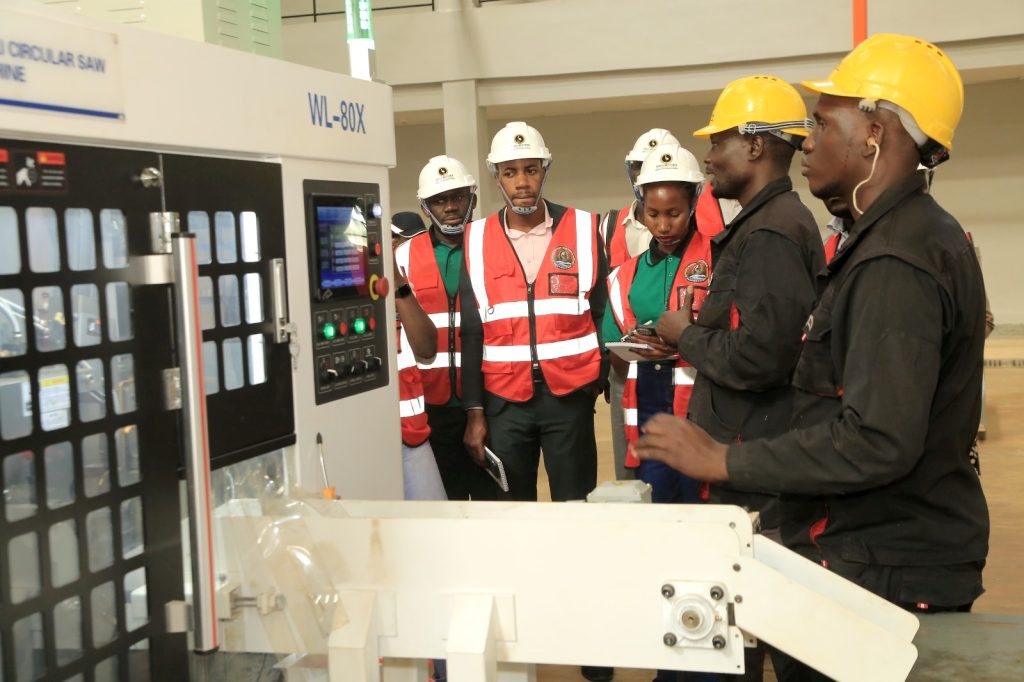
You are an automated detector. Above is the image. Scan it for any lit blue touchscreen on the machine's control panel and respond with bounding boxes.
[314,197,369,294]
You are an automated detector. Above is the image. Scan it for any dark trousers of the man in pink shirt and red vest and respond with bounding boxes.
[487,382,597,502]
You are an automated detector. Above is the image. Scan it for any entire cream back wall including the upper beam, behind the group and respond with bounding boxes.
[285,0,1024,325]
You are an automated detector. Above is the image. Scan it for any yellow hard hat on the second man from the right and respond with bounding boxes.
[693,76,811,141]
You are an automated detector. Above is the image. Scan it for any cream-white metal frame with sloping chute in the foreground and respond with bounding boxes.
[218,493,919,682]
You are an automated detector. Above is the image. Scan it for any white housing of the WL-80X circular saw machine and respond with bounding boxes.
[0,1,402,499]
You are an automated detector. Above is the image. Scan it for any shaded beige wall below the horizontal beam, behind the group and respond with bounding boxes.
[390,80,1024,325]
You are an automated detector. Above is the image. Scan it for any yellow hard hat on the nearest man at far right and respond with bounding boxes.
[801,33,964,150]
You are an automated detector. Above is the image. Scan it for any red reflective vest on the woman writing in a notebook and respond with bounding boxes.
[608,225,721,467]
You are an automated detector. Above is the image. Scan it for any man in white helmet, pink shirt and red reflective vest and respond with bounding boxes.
[462,122,607,501]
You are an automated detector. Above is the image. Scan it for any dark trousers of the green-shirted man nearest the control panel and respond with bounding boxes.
[427,404,502,500]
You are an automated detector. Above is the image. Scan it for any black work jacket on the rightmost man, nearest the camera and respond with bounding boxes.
[727,173,988,604]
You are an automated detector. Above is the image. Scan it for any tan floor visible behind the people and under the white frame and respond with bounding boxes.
[537,336,1024,682]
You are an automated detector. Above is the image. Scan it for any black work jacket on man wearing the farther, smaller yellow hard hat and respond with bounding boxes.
[679,177,824,528]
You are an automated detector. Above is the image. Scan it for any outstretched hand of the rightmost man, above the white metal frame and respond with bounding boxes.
[633,414,729,483]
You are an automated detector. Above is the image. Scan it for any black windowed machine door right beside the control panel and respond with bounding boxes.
[162,155,295,468]
